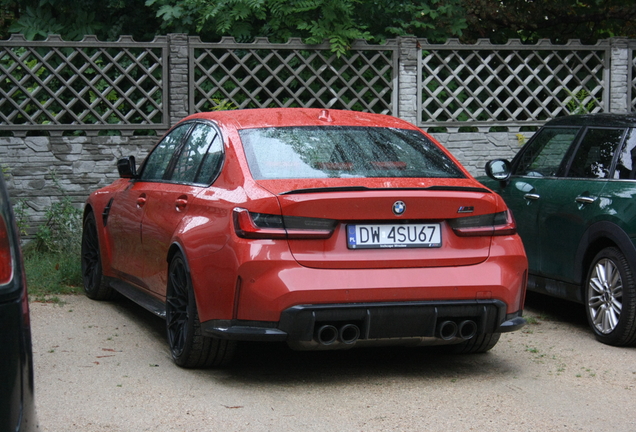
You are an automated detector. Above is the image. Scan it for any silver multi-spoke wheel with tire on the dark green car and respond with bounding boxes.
[584,247,636,346]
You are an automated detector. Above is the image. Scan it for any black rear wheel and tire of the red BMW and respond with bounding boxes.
[166,252,236,368]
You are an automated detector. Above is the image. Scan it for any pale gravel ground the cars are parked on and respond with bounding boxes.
[31,296,636,432]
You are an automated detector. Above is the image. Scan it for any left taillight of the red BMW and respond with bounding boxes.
[234,208,337,239]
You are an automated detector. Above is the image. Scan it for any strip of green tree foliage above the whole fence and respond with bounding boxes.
[0,0,636,53]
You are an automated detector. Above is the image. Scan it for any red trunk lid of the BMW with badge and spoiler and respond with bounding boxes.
[258,179,497,269]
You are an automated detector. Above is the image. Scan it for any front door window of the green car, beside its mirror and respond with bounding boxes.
[513,128,580,177]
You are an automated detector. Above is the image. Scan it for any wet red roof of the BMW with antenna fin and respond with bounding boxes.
[184,108,417,129]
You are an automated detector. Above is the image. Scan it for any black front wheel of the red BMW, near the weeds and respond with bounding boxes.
[82,213,115,300]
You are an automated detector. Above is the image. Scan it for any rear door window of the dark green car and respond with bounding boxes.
[567,128,625,179]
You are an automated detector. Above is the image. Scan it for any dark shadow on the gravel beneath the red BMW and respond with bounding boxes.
[104,292,519,386]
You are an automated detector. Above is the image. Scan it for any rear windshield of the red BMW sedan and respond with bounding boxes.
[240,126,464,180]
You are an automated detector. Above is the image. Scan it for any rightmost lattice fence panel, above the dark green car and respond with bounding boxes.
[419,41,610,126]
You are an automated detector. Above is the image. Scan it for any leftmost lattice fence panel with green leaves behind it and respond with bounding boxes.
[0,35,168,130]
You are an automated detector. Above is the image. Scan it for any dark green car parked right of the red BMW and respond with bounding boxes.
[483,114,636,346]
